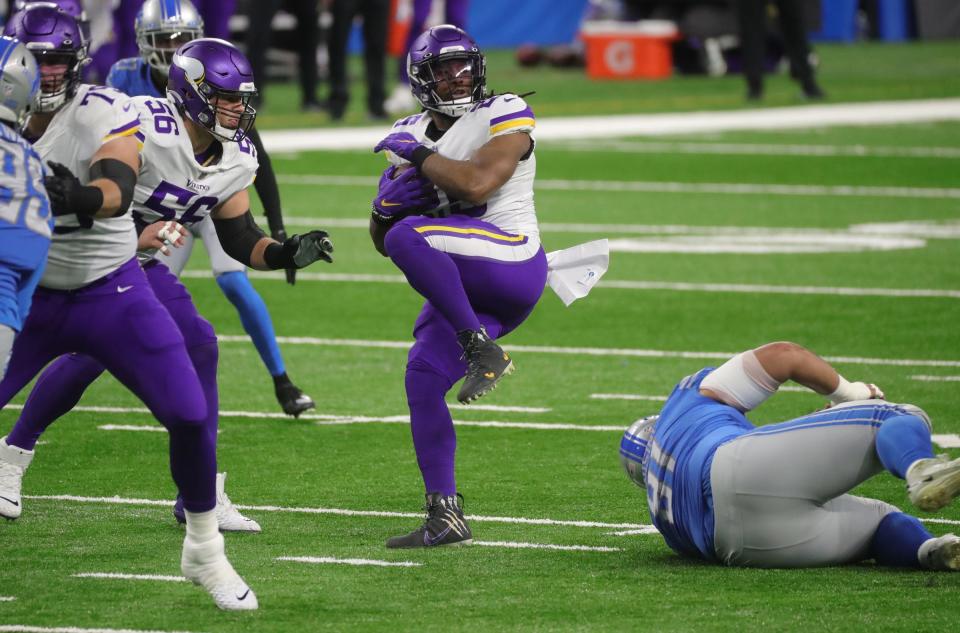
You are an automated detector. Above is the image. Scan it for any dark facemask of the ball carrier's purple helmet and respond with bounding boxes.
[407,48,487,118]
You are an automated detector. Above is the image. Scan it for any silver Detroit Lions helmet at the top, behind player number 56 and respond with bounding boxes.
[133,0,203,75]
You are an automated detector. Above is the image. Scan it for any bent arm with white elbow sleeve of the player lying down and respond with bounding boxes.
[700,342,883,411]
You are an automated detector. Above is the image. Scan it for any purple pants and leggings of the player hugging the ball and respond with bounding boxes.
[384,215,547,495]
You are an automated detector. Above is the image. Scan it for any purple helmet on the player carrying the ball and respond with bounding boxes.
[407,24,487,118]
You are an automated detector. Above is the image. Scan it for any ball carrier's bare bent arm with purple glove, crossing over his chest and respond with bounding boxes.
[374,132,533,205]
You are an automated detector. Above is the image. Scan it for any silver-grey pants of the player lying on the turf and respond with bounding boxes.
[710,400,909,567]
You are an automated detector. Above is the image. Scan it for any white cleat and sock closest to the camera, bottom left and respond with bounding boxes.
[180,532,260,611]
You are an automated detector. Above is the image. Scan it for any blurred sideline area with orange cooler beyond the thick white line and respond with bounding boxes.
[0,0,960,127]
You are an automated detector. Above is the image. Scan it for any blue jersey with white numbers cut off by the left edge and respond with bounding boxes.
[0,123,53,270]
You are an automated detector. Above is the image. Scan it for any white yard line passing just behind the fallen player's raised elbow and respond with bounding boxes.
[217,334,960,367]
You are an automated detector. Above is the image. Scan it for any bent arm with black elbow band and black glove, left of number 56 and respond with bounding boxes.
[44,136,140,218]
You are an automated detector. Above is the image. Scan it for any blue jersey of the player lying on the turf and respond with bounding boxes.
[643,367,755,560]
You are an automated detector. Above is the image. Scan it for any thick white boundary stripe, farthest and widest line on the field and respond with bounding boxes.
[262,99,960,153]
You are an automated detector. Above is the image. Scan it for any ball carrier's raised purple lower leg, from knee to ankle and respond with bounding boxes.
[384,224,480,332]
